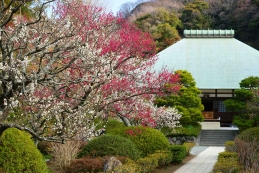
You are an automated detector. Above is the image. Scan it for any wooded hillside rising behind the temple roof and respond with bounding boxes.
[120,0,259,52]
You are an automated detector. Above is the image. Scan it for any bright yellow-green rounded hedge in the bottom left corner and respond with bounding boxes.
[0,128,48,173]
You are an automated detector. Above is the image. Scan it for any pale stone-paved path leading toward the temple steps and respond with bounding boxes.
[174,146,225,173]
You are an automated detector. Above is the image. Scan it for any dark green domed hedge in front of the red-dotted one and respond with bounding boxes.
[78,134,141,160]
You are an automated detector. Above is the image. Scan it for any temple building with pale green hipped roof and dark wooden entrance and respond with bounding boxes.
[154,30,259,127]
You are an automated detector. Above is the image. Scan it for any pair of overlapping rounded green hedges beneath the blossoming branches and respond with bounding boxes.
[78,126,169,160]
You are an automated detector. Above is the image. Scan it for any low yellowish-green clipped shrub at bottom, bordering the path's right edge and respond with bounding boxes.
[212,152,242,173]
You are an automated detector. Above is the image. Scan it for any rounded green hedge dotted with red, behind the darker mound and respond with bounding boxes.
[109,126,172,157]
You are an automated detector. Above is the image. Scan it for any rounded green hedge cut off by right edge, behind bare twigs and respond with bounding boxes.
[238,127,259,142]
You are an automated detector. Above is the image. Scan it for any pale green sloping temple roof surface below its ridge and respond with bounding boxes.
[154,30,259,89]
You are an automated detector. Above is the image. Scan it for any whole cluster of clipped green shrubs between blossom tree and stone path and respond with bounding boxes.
[74,126,190,172]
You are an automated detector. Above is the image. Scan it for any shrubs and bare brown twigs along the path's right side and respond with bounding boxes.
[219,127,259,172]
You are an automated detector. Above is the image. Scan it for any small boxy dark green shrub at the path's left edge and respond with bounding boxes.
[170,145,186,163]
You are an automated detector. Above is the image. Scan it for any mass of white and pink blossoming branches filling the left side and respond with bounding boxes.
[0,0,183,142]
